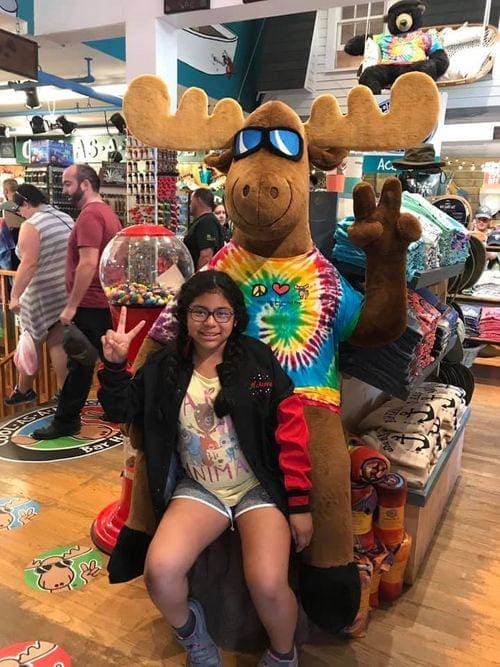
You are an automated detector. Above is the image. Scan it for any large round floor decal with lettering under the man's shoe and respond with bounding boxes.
[0,399,122,463]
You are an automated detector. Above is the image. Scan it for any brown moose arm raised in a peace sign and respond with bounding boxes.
[349,178,421,347]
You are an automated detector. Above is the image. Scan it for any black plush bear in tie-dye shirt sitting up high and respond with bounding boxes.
[344,0,448,95]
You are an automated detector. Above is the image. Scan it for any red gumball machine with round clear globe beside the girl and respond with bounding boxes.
[91,225,194,553]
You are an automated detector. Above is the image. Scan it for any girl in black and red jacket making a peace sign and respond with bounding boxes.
[99,271,312,667]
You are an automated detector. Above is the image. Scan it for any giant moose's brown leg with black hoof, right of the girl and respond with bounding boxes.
[300,406,361,633]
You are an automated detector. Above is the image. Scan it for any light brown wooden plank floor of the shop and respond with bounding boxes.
[0,384,500,667]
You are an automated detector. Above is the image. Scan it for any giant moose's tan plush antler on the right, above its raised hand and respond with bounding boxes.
[304,72,439,151]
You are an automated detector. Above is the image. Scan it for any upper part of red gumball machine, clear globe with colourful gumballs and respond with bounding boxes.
[100,225,194,363]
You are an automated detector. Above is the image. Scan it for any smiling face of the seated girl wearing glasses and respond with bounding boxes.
[187,292,235,355]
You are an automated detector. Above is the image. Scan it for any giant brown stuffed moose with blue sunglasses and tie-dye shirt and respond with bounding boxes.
[109,73,439,648]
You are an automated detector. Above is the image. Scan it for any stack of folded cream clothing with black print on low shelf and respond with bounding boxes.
[359,382,466,487]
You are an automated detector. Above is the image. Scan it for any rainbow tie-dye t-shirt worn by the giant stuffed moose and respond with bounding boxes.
[209,241,363,409]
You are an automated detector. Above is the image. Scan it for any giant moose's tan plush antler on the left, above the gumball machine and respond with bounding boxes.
[123,74,244,151]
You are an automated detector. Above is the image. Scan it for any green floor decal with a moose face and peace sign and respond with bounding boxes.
[24,544,102,592]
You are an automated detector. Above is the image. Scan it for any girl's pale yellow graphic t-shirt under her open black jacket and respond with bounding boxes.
[178,371,259,507]
